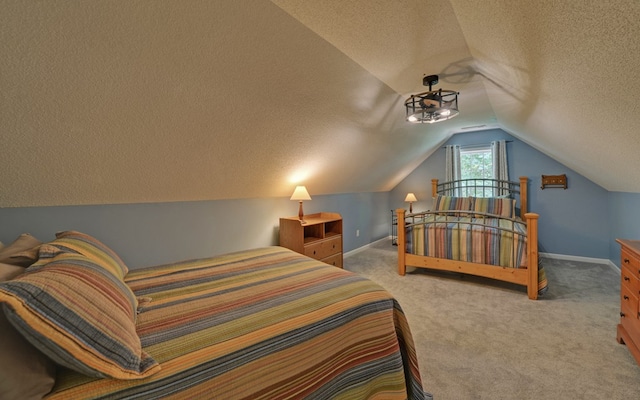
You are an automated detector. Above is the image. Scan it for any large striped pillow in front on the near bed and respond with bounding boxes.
[0,252,160,379]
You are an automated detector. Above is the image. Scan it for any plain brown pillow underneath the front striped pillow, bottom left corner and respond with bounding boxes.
[0,264,56,399]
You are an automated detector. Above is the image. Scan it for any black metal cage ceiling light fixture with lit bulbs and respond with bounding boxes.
[404,75,460,124]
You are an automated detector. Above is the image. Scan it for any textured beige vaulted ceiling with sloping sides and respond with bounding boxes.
[0,0,640,207]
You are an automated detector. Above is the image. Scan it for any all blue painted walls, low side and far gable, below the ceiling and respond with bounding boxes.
[0,130,640,268]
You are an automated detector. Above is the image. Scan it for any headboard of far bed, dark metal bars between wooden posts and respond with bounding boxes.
[431,176,529,219]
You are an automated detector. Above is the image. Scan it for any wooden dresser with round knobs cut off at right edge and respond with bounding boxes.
[616,239,640,364]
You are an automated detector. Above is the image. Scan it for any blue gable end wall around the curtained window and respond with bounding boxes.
[390,129,612,259]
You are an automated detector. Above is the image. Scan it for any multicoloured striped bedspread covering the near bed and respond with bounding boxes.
[47,246,430,400]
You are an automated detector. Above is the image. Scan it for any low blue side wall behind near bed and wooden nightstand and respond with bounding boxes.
[0,192,390,268]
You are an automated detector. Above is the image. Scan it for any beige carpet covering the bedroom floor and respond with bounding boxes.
[344,240,640,400]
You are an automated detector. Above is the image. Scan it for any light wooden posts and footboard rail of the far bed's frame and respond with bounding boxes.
[396,176,538,300]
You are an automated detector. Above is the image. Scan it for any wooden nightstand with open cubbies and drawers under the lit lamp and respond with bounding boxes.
[280,212,342,268]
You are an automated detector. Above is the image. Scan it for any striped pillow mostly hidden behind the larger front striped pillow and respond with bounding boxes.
[39,231,129,279]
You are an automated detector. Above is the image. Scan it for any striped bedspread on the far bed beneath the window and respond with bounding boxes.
[406,214,527,268]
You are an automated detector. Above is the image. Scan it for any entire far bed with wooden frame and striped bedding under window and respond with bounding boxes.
[397,177,547,300]
